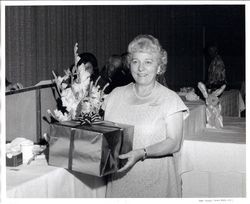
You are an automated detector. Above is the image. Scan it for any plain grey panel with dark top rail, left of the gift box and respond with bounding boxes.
[5,84,58,143]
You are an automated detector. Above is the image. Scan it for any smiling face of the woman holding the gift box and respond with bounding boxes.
[130,52,159,85]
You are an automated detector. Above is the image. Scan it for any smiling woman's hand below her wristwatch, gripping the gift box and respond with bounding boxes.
[118,149,144,172]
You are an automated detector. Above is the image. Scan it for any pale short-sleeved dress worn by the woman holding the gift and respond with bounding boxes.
[104,82,187,198]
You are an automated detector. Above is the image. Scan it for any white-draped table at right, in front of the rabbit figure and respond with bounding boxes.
[178,117,246,198]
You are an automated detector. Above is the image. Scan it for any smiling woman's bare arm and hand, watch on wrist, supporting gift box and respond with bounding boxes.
[118,112,183,172]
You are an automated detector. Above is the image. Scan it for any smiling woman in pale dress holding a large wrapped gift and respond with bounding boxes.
[105,35,188,198]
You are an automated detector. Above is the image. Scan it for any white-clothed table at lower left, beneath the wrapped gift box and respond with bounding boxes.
[6,157,106,198]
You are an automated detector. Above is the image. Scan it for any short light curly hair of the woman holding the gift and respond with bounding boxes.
[127,34,168,74]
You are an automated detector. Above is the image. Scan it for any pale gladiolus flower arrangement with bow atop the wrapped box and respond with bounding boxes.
[48,43,108,124]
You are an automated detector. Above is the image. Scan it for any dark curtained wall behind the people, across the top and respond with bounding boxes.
[5,5,245,90]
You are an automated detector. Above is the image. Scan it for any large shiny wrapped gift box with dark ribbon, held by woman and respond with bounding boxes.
[48,121,134,177]
